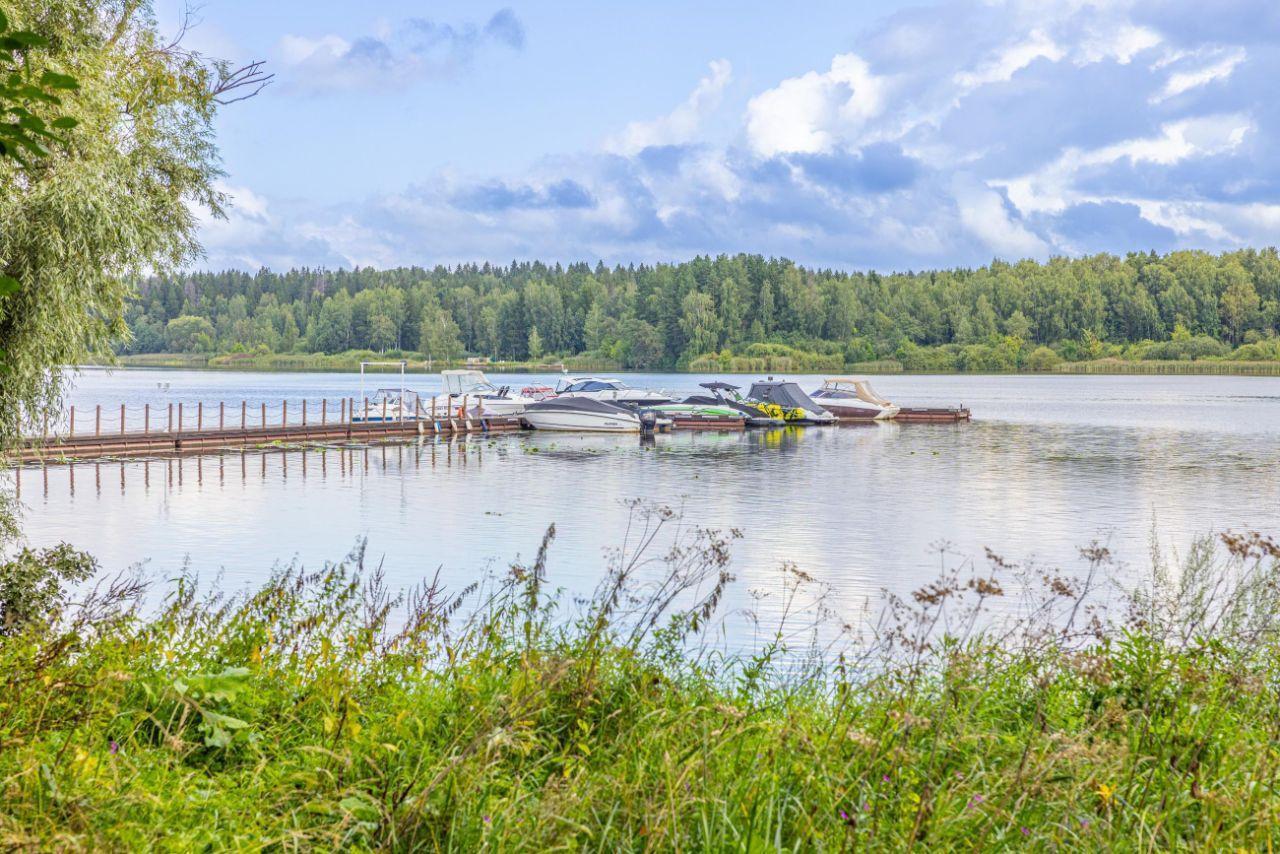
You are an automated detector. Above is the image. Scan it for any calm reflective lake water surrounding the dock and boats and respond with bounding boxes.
[10,370,1280,640]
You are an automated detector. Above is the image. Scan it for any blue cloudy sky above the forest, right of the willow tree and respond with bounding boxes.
[156,0,1280,270]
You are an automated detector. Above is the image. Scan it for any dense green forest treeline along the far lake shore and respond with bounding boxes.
[122,248,1280,370]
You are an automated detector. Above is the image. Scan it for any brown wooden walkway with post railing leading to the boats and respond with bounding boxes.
[10,398,522,462]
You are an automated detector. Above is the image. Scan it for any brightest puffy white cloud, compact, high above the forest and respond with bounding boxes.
[746,54,888,156]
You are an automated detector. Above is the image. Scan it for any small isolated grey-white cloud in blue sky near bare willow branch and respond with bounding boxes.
[276,9,525,92]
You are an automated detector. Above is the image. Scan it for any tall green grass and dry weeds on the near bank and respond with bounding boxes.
[0,507,1280,851]
